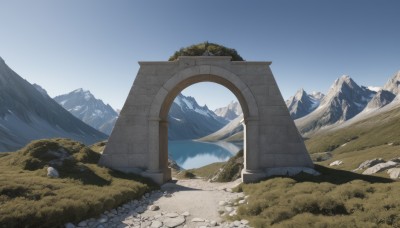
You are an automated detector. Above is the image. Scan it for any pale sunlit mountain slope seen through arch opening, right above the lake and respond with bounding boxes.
[199,113,243,142]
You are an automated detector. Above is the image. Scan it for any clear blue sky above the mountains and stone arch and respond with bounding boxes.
[0,0,400,109]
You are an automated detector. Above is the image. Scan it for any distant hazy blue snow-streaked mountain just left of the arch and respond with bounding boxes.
[54,89,118,135]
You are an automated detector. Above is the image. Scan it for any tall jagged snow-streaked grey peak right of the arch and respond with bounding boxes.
[295,75,376,134]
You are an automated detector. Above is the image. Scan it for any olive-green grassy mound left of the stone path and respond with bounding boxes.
[0,139,156,227]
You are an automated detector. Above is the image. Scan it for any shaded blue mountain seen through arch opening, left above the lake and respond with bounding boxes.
[168,94,228,140]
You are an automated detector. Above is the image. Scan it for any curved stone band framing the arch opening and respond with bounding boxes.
[148,66,258,181]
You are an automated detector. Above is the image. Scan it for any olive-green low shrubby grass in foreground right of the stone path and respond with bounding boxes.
[235,165,400,227]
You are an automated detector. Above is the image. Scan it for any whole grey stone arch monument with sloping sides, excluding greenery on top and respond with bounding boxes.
[100,56,313,184]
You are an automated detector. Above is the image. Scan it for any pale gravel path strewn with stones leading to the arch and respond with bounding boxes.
[65,179,252,228]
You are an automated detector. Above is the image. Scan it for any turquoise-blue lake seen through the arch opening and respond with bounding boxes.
[168,140,243,169]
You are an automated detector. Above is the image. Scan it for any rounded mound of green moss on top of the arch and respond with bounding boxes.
[168,41,244,61]
